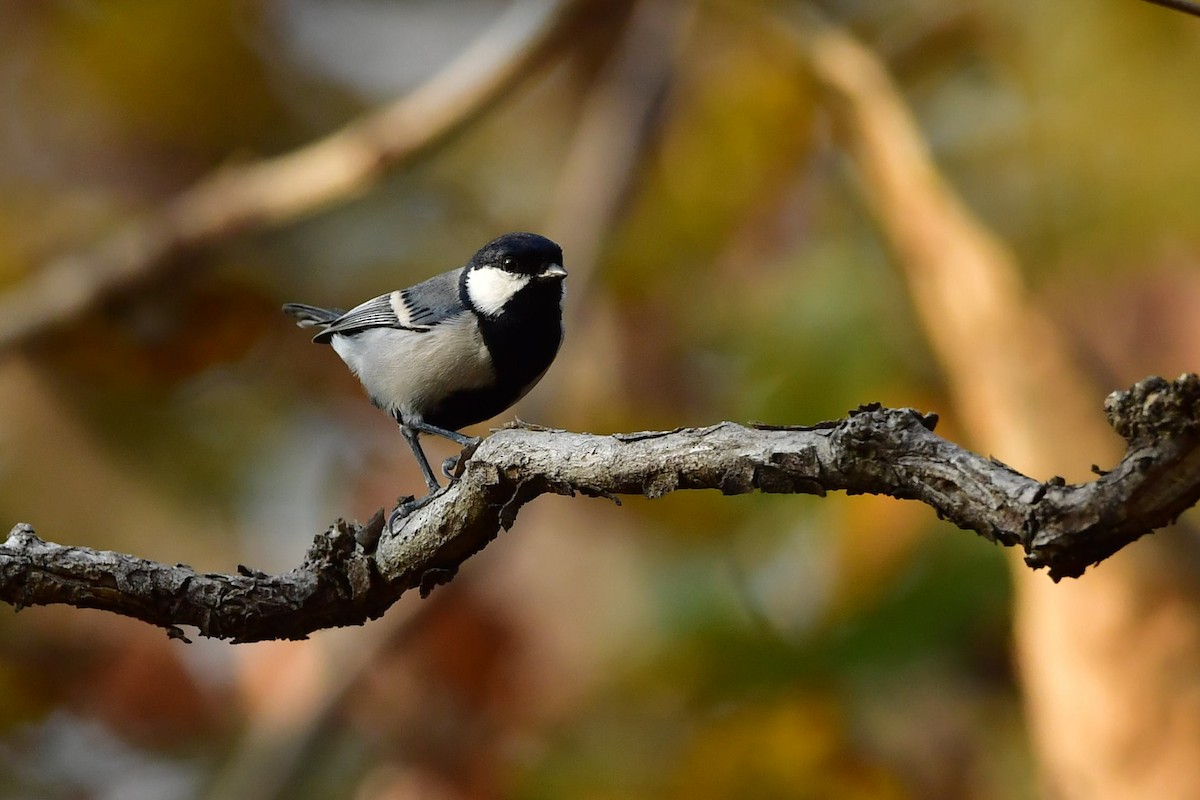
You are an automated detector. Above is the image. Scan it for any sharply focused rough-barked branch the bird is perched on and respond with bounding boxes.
[0,374,1200,642]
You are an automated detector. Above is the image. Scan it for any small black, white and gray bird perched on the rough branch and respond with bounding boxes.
[283,233,566,495]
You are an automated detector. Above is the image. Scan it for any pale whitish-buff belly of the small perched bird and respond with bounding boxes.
[330,314,494,421]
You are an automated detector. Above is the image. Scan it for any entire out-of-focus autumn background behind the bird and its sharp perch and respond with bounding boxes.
[0,0,1200,800]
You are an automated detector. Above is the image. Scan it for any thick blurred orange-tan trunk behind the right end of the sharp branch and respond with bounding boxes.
[775,7,1200,800]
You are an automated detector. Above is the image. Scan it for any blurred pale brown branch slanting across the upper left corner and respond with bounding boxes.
[0,0,604,350]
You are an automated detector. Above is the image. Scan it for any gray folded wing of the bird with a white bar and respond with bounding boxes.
[313,270,463,342]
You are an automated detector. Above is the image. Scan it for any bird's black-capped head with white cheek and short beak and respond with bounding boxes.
[463,233,566,317]
